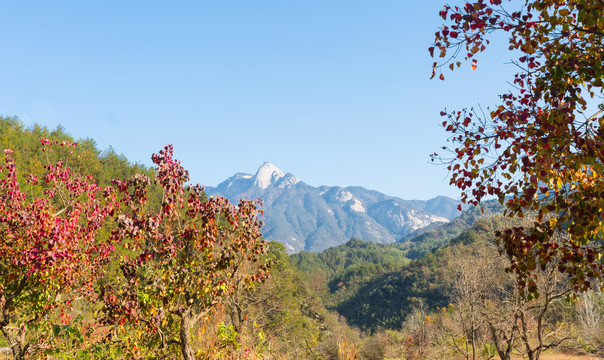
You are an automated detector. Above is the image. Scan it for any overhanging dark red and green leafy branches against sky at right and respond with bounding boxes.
[429,0,604,295]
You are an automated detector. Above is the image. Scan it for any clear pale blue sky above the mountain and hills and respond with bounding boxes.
[0,0,514,199]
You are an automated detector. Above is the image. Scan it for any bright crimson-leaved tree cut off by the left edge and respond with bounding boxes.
[0,139,117,359]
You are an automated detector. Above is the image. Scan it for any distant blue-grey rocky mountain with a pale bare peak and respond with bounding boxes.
[206,162,458,253]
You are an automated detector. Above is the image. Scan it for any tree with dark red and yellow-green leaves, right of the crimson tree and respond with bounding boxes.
[101,145,270,360]
